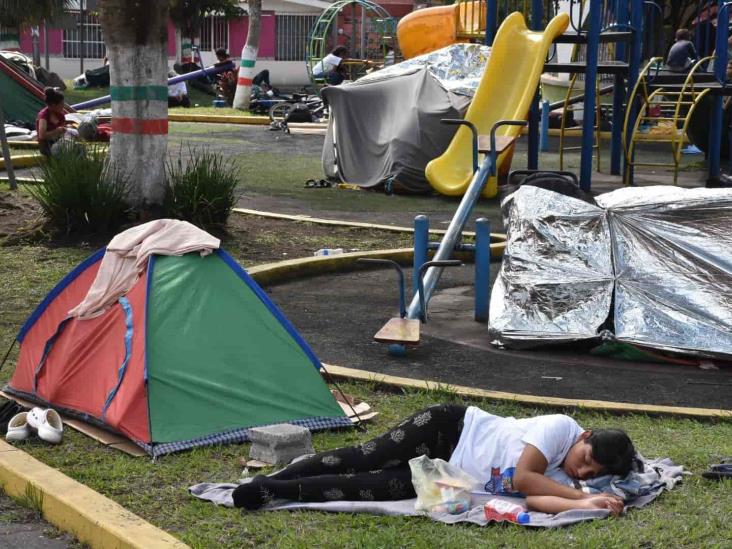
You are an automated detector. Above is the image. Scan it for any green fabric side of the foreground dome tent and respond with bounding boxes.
[146,254,343,443]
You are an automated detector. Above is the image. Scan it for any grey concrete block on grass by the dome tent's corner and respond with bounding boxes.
[249,423,315,465]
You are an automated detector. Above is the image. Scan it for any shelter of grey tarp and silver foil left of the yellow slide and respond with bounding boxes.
[321,44,490,193]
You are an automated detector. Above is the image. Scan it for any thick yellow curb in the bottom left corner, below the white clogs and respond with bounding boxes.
[0,441,188,549]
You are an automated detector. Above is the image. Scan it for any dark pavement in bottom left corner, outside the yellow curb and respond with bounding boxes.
[0,494,73,549]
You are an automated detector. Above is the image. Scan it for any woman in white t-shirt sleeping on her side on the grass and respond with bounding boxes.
[233,404,636,516]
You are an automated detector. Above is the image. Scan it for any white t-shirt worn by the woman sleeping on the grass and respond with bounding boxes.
[450,406,583,494]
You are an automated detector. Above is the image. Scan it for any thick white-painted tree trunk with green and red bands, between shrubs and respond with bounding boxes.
[100,0,168,209]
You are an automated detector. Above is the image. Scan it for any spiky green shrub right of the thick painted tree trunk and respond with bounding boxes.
[163,147,239,227]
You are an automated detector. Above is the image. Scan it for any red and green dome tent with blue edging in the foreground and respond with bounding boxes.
[5,250,351,456]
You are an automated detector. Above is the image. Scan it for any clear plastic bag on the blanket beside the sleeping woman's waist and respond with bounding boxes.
[409,456,478,515]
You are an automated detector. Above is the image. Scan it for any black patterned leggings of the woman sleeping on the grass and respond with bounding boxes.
[233,404,466,509]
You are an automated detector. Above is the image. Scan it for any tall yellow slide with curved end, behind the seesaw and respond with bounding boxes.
[425,12,569,198]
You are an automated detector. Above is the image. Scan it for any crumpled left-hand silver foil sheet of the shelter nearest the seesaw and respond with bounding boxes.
[489,185,614,347]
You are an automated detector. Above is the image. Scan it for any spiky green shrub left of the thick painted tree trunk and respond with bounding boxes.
[28,145,129,234]
